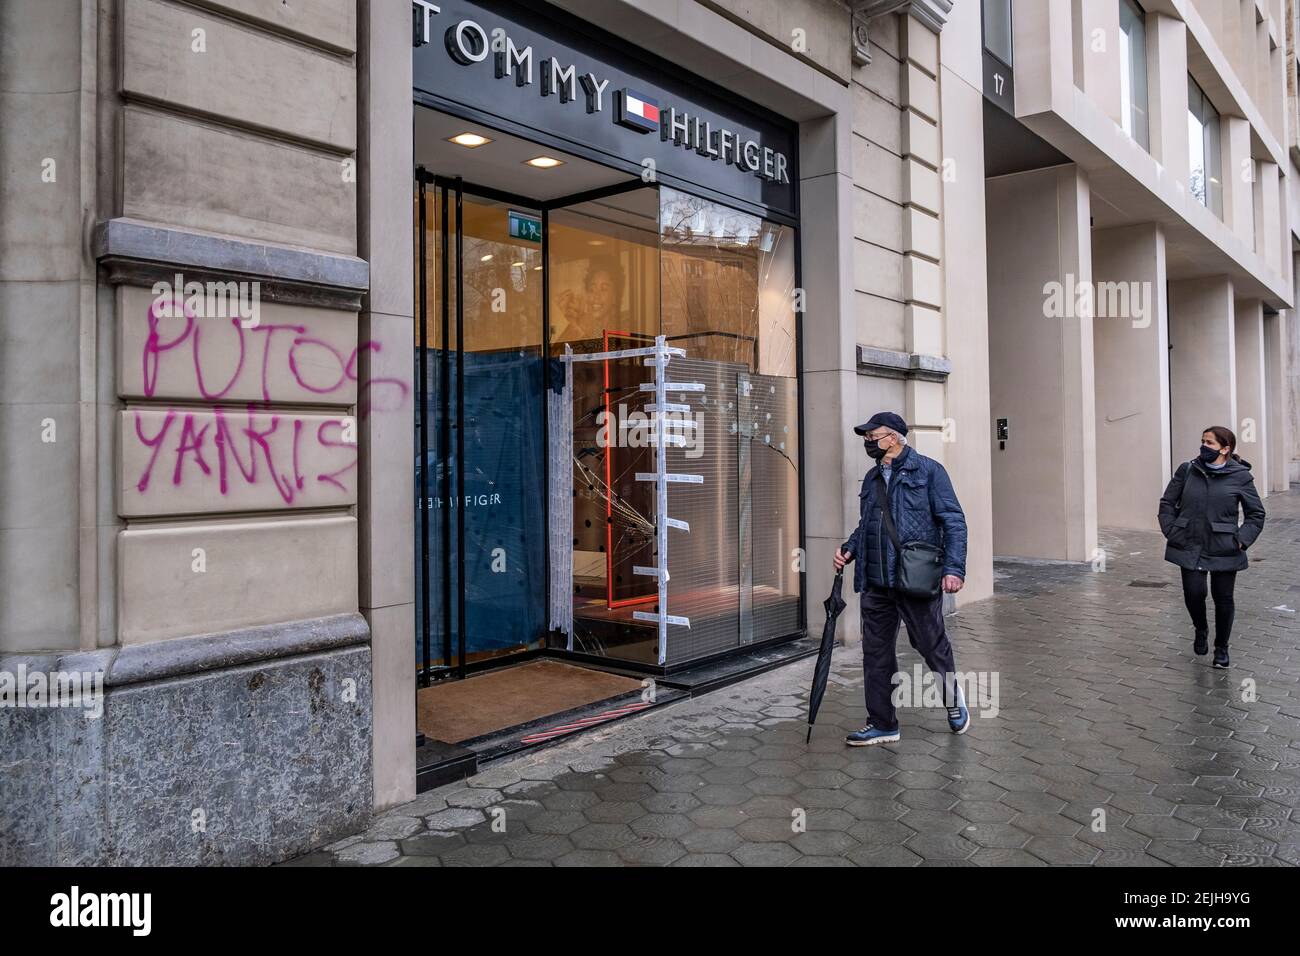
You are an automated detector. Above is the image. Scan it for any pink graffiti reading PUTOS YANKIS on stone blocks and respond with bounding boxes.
[120,300,410,516]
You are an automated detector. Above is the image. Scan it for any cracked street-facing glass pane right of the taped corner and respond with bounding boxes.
[659,189,800,659]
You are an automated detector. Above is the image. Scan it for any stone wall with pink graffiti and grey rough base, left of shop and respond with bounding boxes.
[0,0,382,864]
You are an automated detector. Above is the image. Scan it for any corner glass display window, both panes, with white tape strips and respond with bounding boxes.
[549,189,802,666]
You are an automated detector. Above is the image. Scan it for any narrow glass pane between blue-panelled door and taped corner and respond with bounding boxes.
[546,182,659,663]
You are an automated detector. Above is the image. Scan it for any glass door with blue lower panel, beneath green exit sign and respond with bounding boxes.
[415,174,546,684]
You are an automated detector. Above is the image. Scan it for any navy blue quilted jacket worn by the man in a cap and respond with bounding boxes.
[840,446,966,591]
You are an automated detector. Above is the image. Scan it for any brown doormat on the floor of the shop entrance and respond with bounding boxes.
[416,659,641,744]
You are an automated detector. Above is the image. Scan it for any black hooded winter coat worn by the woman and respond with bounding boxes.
[1160,458,1264,571]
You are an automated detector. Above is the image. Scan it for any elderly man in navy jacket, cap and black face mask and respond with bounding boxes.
[835,411,970,747]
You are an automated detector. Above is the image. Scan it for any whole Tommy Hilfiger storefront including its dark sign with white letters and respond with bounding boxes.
[413,0,805,784]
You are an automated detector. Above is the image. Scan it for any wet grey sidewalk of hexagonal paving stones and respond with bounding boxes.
[290,492,1300,866]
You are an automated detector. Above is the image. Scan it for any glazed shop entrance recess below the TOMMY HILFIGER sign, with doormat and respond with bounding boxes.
[413,108,803,757]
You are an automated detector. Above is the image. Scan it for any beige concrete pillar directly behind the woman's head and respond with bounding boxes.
[1169,276,1238,462]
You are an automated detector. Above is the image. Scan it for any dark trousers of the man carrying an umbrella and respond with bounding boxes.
[862,588,957,730]
